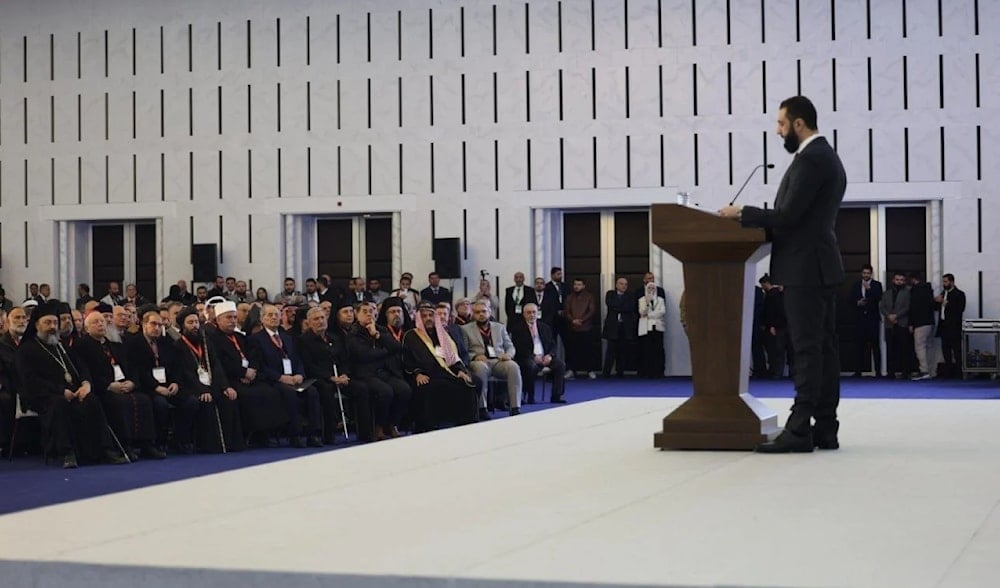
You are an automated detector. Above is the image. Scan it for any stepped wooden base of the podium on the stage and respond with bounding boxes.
[653,394,779,451]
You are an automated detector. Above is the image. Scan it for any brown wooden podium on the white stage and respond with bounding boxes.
[651,204,778,450]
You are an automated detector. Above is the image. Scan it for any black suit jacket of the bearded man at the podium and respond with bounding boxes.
[741,137,847,286]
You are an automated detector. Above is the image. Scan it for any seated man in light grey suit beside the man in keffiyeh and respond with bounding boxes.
[462,300,521,420]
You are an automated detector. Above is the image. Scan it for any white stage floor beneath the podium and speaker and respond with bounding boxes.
[0,398,1000,588]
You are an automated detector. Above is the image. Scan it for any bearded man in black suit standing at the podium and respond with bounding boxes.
[719,96,847,453]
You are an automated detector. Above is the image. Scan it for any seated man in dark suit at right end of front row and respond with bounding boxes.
[510,302,566,404]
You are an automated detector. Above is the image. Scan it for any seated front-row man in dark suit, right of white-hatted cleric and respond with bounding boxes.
[250,304,323,447]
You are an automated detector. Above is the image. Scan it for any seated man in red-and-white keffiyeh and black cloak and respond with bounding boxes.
[403,303,478,430]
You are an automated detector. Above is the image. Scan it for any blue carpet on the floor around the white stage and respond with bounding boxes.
[0,378,1000,514]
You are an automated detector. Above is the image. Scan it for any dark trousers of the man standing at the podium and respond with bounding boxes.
[785,286,840,435]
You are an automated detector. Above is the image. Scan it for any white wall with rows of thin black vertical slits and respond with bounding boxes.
[0,0,1000,373]
